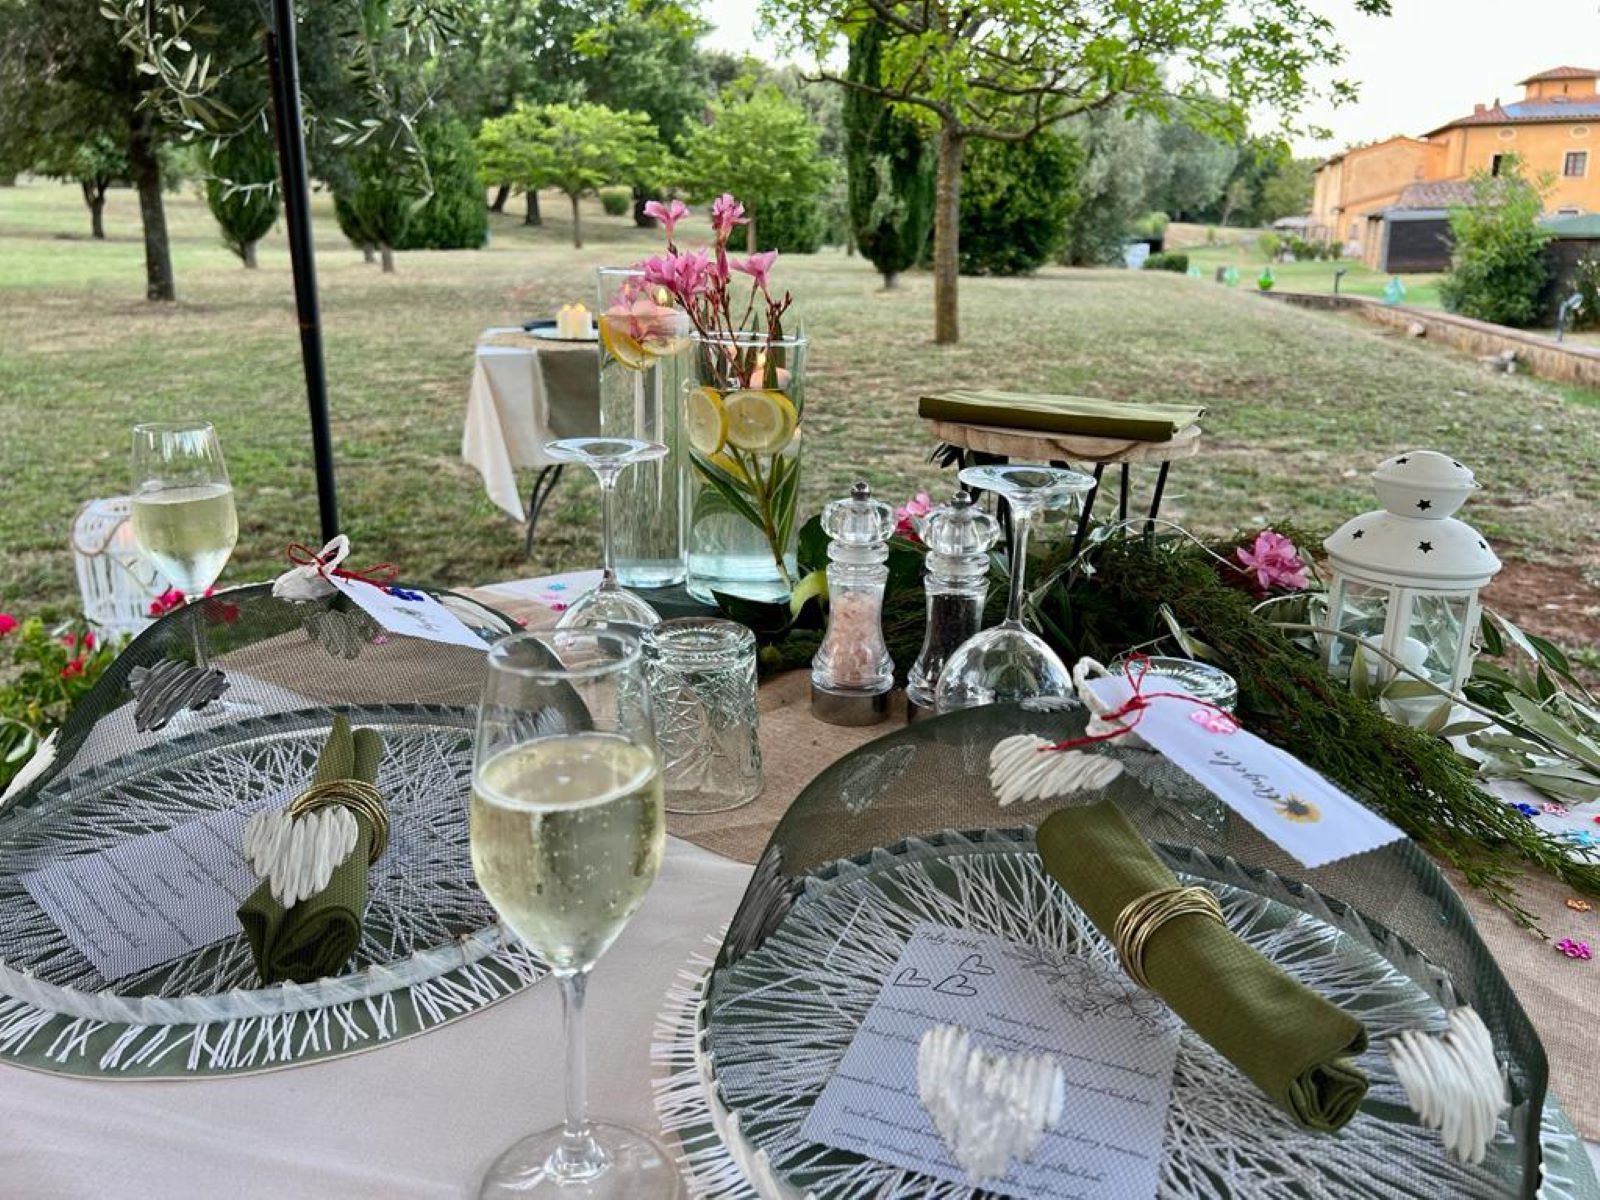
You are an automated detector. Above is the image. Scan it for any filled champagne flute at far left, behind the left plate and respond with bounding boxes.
[133,421,246,684]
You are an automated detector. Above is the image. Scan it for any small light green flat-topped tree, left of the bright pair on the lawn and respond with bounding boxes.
[477,104,664,248]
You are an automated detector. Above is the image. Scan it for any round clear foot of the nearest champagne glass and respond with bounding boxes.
[478,1122,683,1200]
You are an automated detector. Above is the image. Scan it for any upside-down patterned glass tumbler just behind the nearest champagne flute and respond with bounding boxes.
[645,616,762,813]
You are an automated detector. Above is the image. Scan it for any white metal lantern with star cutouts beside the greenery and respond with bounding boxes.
[1320,450,1501,691]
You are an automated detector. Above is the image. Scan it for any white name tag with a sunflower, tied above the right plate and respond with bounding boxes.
[1088,678,1405,867]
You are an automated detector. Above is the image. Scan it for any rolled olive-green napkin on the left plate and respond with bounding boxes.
[238,715,384,984]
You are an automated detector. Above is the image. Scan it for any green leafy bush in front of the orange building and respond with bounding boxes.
[1438,155,1550,325]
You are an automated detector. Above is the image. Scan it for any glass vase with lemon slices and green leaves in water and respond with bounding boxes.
[682,333,806,603]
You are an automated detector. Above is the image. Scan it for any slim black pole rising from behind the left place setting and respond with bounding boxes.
[267,0,339,542]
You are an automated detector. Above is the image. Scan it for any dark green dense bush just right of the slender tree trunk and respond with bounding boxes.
[960,131,1083,275]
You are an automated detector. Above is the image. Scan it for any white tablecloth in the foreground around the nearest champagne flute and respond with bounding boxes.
[0,838,750,1200]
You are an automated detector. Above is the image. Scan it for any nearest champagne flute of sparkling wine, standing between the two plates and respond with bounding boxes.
[470,627,680,1200]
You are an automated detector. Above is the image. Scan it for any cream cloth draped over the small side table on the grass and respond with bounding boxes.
[461,328,600,520]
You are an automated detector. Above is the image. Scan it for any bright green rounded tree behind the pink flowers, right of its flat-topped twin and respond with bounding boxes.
[677,85,832,253]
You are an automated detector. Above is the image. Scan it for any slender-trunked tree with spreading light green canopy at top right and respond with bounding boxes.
[762,0,1389,342]
